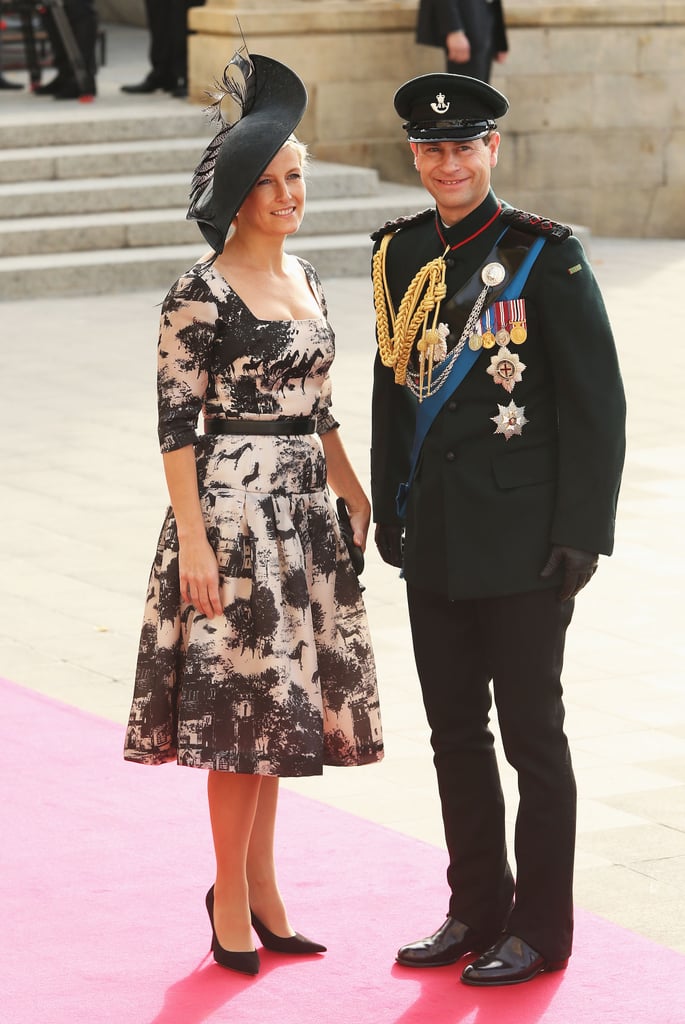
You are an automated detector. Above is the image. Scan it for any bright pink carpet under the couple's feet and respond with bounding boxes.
[0,680,685,1024]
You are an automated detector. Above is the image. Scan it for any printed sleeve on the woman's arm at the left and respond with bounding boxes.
[157,273,217,454]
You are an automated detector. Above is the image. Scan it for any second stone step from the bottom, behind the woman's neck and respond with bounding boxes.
[0,185,426,257]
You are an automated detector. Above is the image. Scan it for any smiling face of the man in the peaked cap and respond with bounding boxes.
[412,132,500,225]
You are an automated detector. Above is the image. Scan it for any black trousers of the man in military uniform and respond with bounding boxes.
[408,586,575,959]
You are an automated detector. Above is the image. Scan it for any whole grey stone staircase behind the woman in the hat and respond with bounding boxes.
[0,109,427,299]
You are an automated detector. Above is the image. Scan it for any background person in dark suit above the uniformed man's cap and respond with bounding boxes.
[417,0,508,82]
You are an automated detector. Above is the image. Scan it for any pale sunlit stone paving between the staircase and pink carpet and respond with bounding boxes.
[0,18,685,952]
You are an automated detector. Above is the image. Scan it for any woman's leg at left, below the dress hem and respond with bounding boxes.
[207,771,266,952]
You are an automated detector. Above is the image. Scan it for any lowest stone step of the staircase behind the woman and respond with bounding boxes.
[0,233,372,300]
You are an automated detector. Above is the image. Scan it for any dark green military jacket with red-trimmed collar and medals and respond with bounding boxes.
[371,191,625,599]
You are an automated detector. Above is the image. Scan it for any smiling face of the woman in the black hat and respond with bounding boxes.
[237,142,306,236]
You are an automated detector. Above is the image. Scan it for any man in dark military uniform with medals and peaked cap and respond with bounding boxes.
[372,74,625,985]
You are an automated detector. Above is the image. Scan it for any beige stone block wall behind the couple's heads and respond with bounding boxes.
[100,0,685,238]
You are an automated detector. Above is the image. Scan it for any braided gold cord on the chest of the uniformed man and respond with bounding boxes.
[372,231,449,392]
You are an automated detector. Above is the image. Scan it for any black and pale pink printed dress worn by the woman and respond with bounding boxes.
[124,260,383,776]
